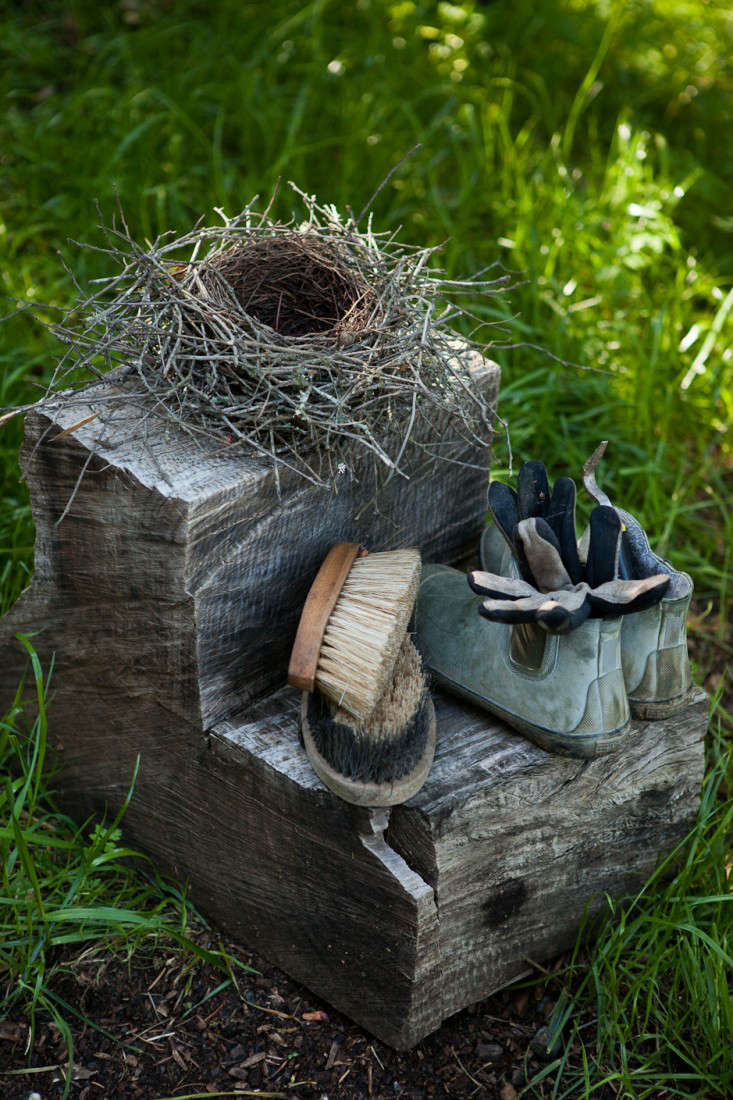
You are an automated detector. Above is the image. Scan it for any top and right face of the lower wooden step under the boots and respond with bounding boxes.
[386,692,707,1015]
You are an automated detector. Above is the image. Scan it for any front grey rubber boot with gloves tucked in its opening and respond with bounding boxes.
[415,565,630,758]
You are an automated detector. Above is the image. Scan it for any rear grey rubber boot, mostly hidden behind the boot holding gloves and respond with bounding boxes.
[481,521,692,719]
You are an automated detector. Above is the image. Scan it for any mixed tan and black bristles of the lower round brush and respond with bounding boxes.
[308,636,430,783]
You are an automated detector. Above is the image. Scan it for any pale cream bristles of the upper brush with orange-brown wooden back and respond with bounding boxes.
[316,549,420,722]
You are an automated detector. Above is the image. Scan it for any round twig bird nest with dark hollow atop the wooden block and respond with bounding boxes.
[19,188,506,484]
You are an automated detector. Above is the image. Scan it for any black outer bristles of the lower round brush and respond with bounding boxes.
[308,691,430,783]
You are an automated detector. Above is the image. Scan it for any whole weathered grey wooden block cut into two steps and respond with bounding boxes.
[0,365,705,1047]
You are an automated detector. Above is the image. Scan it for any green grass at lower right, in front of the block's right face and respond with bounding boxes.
[530,705,733,1100]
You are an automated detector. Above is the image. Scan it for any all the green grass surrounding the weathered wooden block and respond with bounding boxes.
[0,0,733,1098]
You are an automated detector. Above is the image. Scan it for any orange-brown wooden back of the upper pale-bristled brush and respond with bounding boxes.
[287,542,361,691]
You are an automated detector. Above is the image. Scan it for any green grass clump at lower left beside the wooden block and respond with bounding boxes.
[0,635,250,1097]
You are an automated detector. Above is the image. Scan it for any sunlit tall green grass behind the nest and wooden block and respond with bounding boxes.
[0,0,733,611]
